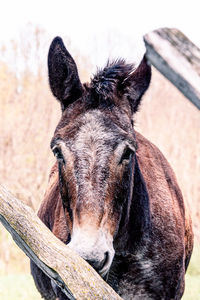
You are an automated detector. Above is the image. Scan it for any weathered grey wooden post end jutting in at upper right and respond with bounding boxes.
[144,28,200,109]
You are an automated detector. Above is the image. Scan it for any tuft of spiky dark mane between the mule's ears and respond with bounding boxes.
[90,58,135,101]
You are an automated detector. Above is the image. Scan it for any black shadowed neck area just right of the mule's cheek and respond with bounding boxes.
[114,155,151,255]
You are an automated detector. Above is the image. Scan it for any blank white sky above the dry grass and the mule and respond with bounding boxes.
[0,0,200,68]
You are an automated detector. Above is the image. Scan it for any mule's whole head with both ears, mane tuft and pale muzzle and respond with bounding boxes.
[48,38,151,276]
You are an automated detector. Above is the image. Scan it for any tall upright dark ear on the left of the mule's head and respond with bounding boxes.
[48,37,83,111]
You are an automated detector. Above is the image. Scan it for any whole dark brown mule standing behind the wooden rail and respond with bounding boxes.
[31,37,193,300]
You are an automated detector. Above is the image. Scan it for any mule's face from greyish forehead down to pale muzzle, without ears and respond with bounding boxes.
[51,110,136,275]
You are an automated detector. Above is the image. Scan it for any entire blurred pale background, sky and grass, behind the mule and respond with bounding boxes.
[0,0,200,300]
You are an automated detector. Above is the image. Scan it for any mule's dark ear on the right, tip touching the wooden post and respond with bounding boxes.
[123,56,151,113]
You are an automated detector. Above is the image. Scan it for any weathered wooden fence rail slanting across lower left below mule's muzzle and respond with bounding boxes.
[0,185,121,300]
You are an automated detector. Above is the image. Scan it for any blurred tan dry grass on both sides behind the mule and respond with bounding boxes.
[0,33,200,298]
